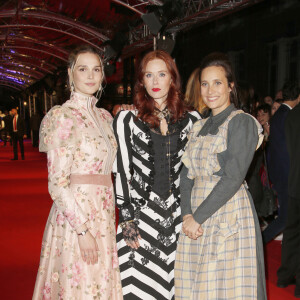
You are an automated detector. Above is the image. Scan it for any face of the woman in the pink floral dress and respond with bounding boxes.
[68,52,103,96]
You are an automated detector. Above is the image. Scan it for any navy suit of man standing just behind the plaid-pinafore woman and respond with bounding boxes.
[263,104,291,243]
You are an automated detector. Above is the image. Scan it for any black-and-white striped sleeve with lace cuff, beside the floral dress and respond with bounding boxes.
[113,111,134,223]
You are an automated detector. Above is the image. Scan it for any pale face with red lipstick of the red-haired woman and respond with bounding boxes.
[143,59,172,108]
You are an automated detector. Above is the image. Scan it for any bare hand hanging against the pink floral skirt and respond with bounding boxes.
[78,231,99,265]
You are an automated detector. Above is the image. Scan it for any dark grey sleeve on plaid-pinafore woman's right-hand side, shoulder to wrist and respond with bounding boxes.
[194,114,258,224]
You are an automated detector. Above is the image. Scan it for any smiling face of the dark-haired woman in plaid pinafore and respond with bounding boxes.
[200,66,233,115]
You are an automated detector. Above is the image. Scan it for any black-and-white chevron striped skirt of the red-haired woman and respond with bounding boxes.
[117,191,181,300]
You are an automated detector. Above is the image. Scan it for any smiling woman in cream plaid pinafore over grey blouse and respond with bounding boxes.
[175,53,267,300]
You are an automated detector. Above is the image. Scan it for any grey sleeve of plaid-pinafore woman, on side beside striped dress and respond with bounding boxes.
[180,165,194,217]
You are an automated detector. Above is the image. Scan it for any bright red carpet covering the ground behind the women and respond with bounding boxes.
[0,141,296,300]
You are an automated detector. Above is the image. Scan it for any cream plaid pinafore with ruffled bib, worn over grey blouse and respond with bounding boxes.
[175,111,260,300]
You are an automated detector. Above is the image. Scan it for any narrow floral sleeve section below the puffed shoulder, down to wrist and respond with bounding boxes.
[47,146,88,229]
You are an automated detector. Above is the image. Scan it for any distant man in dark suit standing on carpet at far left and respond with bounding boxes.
[10,108,27,160]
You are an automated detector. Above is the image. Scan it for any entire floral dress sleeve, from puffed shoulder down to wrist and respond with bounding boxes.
[40,107,88,229]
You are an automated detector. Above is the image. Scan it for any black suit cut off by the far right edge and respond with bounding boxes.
[277,104,300,287]
